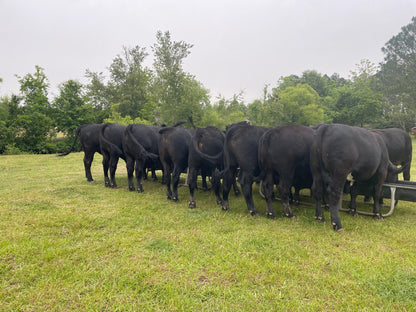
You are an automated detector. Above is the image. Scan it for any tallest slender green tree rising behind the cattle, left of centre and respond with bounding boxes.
[152,31,208,124]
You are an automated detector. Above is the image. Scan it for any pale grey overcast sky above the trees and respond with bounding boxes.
[0,0,416,103]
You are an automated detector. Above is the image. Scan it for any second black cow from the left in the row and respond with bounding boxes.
[99,123,127,188]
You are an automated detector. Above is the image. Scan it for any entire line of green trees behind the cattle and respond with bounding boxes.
[0,17,416,154]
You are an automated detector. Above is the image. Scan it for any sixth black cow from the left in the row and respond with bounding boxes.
[214,122,268,215]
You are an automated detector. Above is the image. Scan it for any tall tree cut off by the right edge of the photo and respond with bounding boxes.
[379,17,416,130]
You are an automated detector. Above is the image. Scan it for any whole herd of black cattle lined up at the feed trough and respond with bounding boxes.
[60,121,412,230]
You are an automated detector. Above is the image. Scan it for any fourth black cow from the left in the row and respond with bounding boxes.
[159,127,192,202]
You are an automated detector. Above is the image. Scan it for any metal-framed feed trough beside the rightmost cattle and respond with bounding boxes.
[339,181,416,217]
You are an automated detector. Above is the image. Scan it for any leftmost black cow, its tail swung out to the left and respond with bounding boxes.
[58,124,103,182]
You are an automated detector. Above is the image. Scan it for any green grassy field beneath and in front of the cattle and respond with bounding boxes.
[0,140,416,311]
